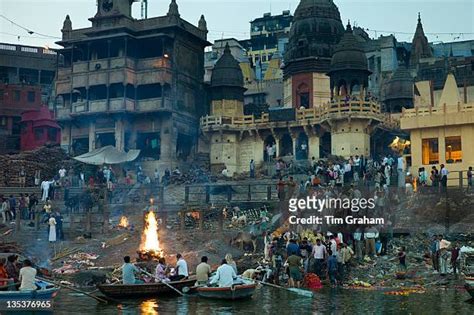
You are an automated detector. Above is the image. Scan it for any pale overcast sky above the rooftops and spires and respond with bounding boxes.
[0,0,474,47]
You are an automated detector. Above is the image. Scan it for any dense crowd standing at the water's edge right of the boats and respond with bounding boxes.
[265,230,388,287]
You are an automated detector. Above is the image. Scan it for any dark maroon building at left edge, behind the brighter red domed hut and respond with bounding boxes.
[0,83,41,153]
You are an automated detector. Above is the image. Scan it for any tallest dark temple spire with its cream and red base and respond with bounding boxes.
[283,0,344,108]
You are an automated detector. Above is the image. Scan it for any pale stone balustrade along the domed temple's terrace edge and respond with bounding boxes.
[201,101,386,128]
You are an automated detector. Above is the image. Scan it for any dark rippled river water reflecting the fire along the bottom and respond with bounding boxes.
[40,287,474,315]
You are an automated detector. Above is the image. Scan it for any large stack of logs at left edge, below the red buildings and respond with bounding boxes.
[0,146,75,187]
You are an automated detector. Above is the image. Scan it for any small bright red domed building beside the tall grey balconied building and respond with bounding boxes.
[21,106,61,151]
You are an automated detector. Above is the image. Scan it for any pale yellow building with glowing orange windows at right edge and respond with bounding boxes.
[400,74,474,186]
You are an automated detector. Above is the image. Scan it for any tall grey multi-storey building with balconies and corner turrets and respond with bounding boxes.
[56,0,209,171]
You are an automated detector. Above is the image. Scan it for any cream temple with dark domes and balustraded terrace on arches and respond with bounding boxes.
[201,0,388,173]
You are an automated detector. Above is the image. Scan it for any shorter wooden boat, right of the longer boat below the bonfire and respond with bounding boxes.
[196,282,257,300]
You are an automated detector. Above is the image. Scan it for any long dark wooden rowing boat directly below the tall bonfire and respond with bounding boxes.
[97,277,196,299]
